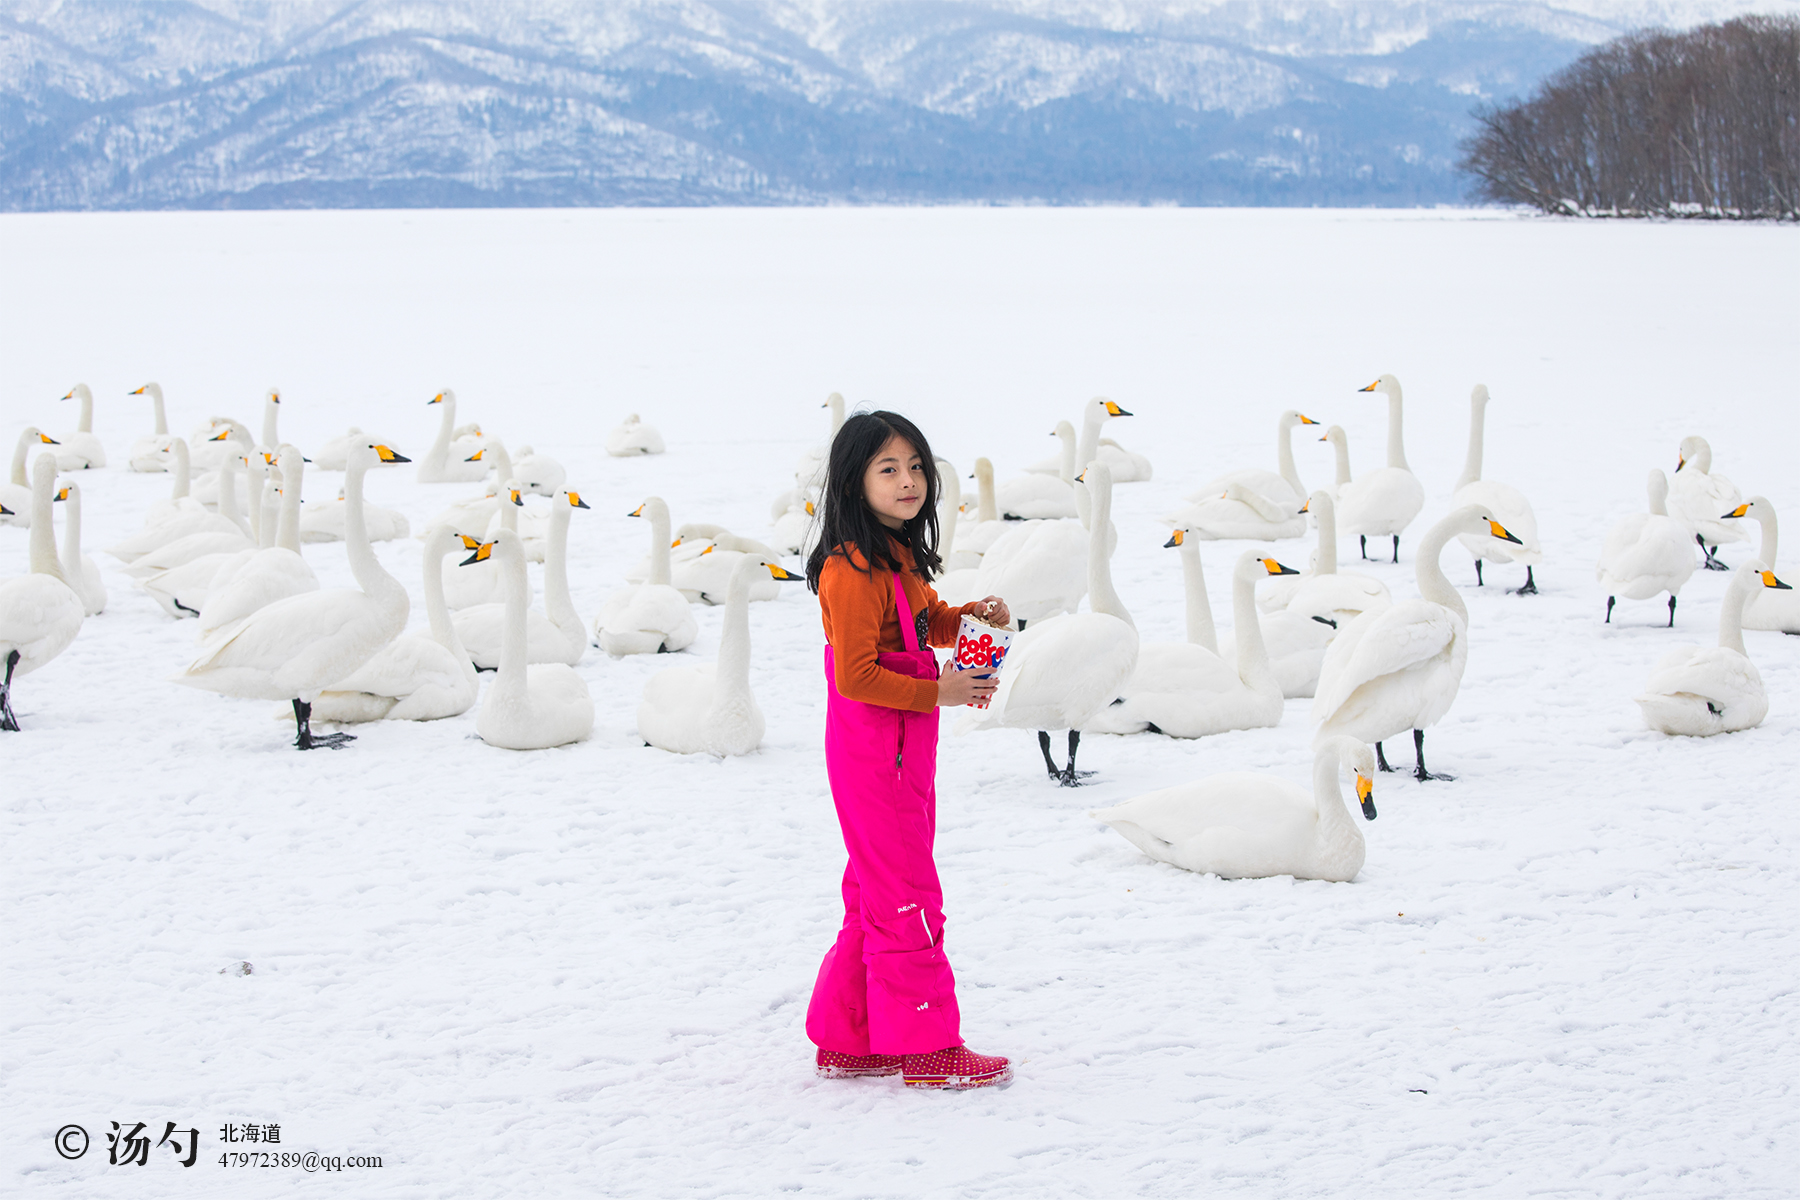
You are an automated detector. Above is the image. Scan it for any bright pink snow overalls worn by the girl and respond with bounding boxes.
[806,572,963,1054]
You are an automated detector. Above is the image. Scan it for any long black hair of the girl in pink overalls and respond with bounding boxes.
[806,412,943,592]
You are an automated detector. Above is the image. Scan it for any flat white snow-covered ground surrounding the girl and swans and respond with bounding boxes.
[0,210,1800,1198]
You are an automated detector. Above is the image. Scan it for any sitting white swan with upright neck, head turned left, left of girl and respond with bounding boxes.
[463,529,594,750]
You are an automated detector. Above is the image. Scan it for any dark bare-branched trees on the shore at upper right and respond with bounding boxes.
[1462,16,1800,219]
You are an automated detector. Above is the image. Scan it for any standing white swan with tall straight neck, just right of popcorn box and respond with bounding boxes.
[958,462,1138,788]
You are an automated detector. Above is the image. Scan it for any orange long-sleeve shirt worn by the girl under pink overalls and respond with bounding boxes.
[819,542,981,712]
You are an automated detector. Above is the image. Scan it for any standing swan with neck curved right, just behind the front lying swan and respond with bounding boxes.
[1312,504,1516,783]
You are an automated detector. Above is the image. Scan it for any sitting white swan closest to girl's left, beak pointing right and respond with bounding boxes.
[637,554,799,756]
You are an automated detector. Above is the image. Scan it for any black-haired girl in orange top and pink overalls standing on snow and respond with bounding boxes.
[806,412,1012,1088]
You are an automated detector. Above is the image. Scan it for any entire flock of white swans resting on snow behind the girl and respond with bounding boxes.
[0,374,1800,880]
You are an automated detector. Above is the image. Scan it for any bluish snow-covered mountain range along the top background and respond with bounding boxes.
[0,0,1778,210]
